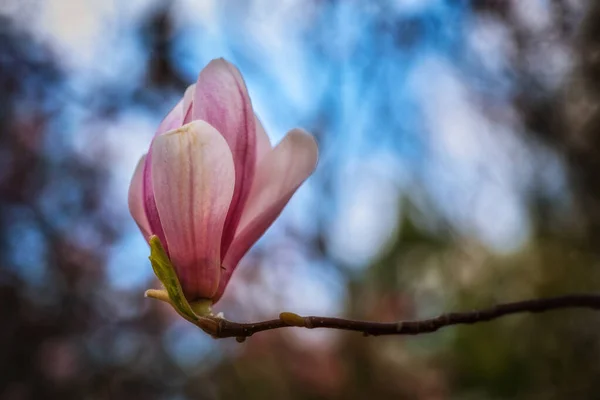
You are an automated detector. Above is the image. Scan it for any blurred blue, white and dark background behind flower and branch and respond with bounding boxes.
[0,0,600,400]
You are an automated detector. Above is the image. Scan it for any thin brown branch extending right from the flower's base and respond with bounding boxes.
[199,294,600,342]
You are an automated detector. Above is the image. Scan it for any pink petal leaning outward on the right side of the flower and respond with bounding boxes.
[215,129,318,302]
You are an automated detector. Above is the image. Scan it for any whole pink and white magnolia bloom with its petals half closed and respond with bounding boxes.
[129,59,317,304]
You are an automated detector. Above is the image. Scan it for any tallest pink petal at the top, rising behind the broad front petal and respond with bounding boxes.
[192,58,256,253]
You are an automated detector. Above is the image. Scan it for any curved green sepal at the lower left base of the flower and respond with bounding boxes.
[148,235,199,322]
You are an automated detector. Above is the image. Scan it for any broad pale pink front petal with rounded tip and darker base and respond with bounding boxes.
[152,121,235,301]
